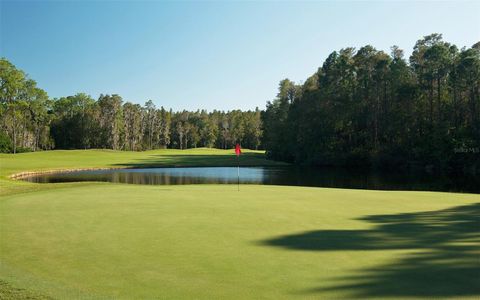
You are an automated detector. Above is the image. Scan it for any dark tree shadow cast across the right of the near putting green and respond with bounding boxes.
[261,203,480,298]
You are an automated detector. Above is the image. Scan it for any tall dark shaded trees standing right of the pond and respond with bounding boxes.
[263,34,480,172]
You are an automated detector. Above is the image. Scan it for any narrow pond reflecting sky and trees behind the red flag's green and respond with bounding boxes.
[23,166,480,193]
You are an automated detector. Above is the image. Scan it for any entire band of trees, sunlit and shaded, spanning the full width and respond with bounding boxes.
[0,34,480,172]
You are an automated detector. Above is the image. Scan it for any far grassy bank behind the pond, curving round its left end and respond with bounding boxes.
[0,148,282,195]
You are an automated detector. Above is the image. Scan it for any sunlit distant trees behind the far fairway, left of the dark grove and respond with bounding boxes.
[0,58,262,153]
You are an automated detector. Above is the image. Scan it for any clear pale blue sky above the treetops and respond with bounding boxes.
[0,0,480,110]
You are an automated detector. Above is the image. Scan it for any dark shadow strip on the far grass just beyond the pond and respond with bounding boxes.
[111,152,284,168]
